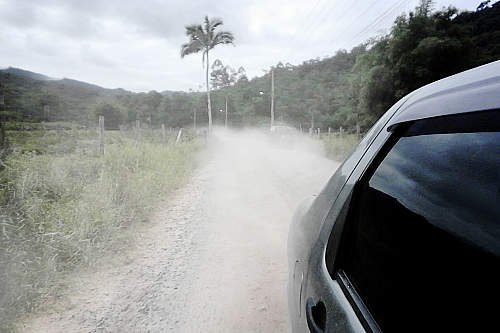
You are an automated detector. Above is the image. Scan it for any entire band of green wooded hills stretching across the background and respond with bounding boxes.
[0,0,500,131]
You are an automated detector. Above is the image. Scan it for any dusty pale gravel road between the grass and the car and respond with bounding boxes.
[22,131,338,332]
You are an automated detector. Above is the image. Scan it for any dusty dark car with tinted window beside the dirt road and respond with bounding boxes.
[287,61,500,332]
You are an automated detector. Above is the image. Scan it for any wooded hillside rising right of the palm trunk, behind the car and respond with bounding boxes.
[213,0,500,131]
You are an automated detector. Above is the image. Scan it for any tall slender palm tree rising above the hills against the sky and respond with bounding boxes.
[181,16,234,132]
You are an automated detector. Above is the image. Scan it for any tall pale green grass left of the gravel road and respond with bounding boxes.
[0,131,199,332]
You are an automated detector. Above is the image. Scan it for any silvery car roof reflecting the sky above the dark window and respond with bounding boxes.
[387,60,500,131]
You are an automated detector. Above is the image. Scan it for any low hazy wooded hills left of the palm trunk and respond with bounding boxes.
[0,69,207,128]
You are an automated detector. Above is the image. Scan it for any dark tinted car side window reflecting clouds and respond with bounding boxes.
[338,111,500,332]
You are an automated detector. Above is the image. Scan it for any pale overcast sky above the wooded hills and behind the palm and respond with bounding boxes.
[0,0,481,91]
